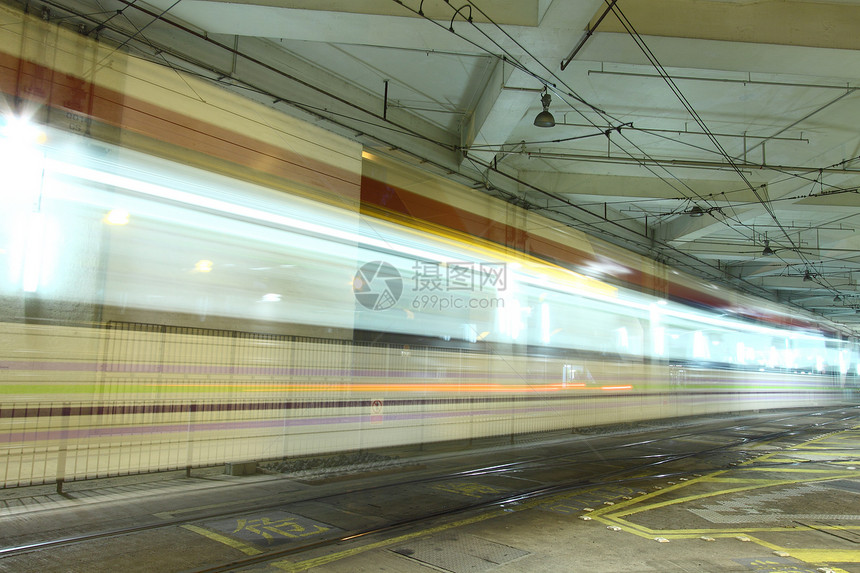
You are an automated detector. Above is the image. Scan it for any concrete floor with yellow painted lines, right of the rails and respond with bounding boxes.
[253,418,860,573]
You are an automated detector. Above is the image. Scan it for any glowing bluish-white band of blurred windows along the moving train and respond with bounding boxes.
[0,126,856,374]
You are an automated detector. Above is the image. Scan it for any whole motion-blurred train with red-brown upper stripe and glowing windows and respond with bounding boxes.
[0,4,860,487]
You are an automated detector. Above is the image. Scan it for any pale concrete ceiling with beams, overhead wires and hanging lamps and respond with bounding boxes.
[11,0,860,329]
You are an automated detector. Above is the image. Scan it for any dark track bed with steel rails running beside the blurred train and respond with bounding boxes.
[0,408,860,573]
